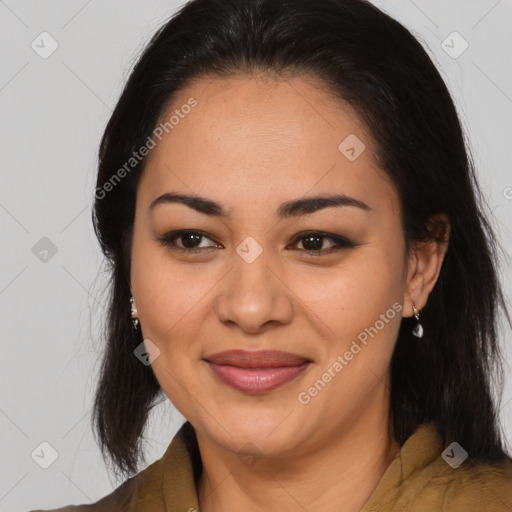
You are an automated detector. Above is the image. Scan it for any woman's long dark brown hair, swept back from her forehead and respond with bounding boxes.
[93,0,510,480]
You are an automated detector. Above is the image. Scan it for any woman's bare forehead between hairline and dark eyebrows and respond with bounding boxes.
[139,77,396,216]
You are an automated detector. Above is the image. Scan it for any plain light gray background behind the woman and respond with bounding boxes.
[0,0,512,512]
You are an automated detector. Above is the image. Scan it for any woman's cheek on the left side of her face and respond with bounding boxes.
[132,244,212,408]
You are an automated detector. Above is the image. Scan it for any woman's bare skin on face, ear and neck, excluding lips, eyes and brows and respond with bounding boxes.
[131,76,447,512]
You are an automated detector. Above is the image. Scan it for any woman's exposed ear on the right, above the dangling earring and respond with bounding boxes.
[403,214,450,317]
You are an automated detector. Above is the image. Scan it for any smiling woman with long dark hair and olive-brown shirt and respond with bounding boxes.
[31,0,512,512]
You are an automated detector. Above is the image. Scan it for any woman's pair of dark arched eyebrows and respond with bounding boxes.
[149,192,371,219]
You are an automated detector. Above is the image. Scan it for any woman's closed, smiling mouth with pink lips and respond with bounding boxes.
[204,350,312,394]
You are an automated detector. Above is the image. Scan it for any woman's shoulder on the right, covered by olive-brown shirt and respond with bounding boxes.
[363,424,512,512]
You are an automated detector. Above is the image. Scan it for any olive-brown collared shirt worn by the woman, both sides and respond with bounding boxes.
[32,424,512,512]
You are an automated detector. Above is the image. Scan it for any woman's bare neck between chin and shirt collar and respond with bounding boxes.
[198,412,400,512]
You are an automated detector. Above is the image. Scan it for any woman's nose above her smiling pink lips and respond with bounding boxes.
[215,253,294,334]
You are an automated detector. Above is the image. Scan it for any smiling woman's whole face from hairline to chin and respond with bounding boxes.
[131,77,410,455]
